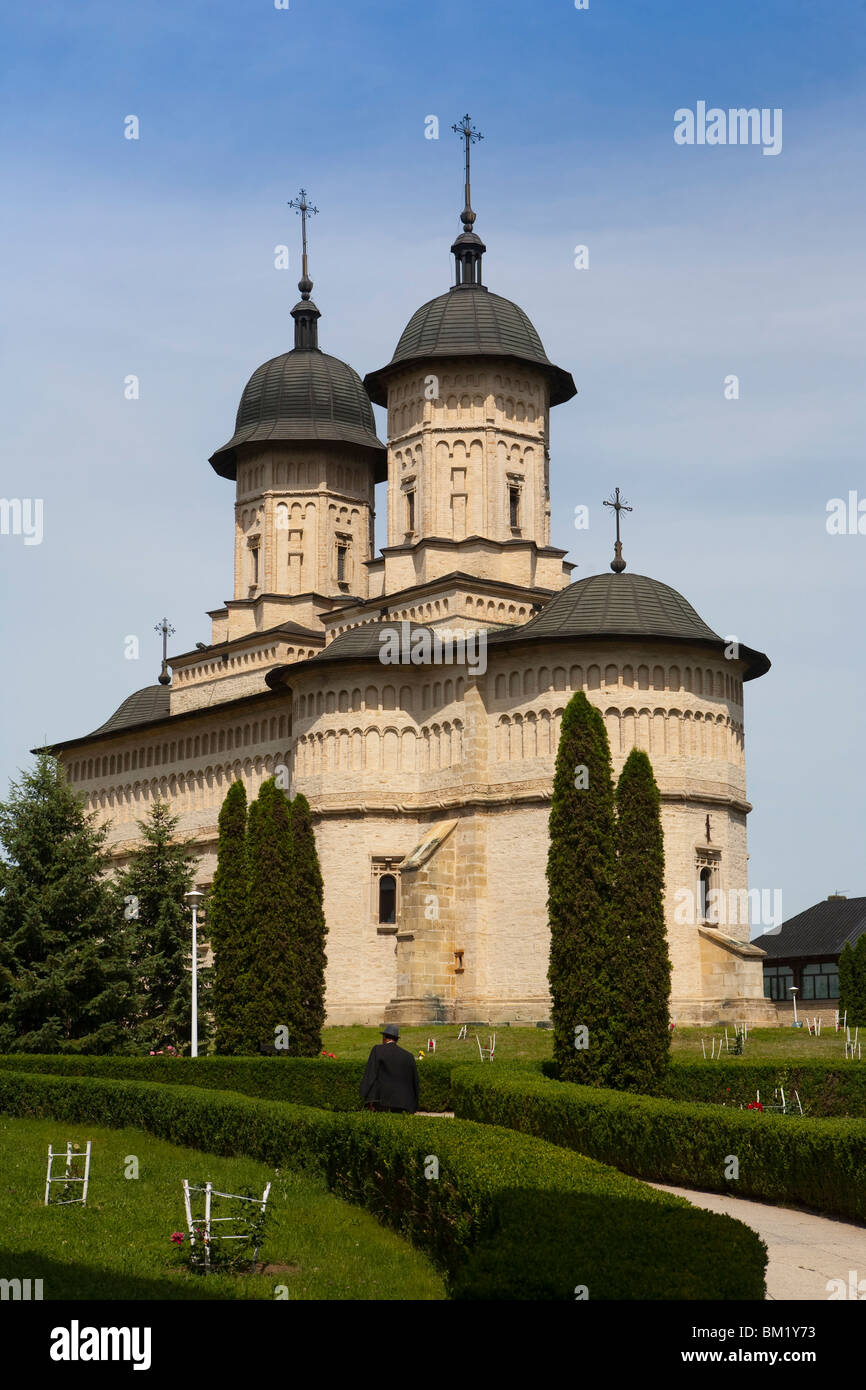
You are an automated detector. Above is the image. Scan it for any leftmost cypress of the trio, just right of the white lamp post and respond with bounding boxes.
[207,781,249,1056]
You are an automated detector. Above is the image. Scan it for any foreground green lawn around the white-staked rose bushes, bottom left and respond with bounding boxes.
[0,1115,446,1300]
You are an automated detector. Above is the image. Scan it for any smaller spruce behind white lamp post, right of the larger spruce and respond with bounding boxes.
[115,801,204,1052]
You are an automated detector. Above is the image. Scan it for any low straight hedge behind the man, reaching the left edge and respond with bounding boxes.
[0,1052,453,1111]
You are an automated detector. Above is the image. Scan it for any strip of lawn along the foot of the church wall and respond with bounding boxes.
[322,1023,866,1065]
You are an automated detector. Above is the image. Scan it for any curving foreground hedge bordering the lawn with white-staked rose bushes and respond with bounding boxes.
[0,1062,766,1301]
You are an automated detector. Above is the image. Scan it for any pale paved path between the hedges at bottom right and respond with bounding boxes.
[649,1183,866,1300]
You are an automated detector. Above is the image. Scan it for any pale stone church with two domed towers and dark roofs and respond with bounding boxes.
[40,118,774,1024]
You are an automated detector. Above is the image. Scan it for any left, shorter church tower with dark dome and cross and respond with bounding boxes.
[210,189,385,641]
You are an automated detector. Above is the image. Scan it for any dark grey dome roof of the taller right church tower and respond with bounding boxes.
[364,285,577,406]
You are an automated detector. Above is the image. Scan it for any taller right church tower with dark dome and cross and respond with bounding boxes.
[364,115,577,611]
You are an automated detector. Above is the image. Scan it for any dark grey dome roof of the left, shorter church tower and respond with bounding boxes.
[210,348,386,482]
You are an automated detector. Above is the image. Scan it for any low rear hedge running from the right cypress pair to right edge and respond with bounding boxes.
[656,1056,866,1119]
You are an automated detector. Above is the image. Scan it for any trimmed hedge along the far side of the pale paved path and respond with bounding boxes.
[461,1068,866,1222]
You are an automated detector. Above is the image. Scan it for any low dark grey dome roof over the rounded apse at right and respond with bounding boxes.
[489,574,770,681]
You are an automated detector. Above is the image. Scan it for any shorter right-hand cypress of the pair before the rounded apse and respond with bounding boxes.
[609,748,670,1091]
